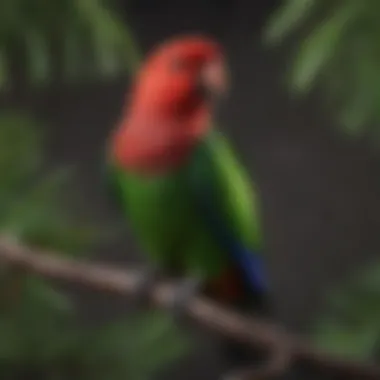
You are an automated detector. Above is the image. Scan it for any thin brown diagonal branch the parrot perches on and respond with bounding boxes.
[0,238,380,380]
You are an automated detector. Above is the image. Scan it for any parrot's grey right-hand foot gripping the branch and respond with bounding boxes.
[169,277,203,321]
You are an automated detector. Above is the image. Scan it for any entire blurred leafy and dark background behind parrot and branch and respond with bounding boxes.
[0,0,380,380]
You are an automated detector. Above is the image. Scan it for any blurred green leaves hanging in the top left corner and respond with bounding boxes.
[0,0,138,89]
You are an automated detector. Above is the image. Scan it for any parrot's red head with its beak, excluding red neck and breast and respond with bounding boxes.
[129,36,226,113]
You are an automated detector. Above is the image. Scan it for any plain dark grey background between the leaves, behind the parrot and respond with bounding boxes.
[6,0,380,379]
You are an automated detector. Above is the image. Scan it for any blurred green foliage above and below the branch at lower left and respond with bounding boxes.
[0,113,190,380]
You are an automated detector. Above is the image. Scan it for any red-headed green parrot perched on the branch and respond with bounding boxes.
[106,34,269,374]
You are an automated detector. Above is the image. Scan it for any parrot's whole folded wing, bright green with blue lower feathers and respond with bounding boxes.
[190,133,267,295]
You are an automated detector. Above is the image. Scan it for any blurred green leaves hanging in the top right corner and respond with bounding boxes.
[265,0,380,136]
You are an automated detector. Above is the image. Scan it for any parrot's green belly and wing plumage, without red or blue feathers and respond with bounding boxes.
[110,131,262,286]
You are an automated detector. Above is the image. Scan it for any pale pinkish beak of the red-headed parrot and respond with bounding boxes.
[200,59,228,98]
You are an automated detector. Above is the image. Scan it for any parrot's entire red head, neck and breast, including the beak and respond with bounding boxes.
[114,36,227,174]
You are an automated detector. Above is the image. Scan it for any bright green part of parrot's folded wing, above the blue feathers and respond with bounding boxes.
[191,131,262,250]
